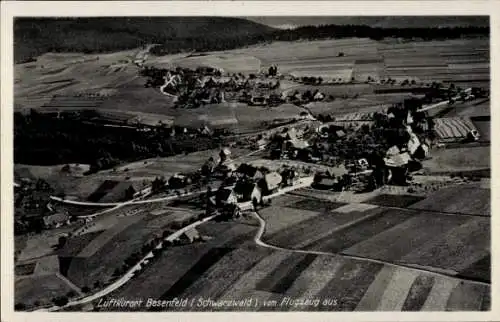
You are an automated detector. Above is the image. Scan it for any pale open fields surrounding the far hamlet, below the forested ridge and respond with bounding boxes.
[14,38,489,131]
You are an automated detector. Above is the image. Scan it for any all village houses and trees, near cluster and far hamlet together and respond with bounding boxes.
[15,56,488,247]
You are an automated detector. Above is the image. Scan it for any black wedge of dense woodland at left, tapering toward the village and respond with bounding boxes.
[14,112,220,172]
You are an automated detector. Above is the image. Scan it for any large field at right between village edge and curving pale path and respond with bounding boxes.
[261,191,490,280]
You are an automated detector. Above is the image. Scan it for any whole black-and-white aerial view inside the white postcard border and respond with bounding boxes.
[13,16,492,312]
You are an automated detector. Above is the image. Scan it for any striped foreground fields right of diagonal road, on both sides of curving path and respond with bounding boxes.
[103,190,491,311]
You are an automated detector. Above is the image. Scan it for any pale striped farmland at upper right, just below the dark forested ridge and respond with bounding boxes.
[227,39,489,87]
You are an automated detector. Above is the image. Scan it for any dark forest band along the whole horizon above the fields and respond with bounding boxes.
[14,17,489,63]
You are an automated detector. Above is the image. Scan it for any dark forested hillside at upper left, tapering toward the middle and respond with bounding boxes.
[14,17,273,62]
